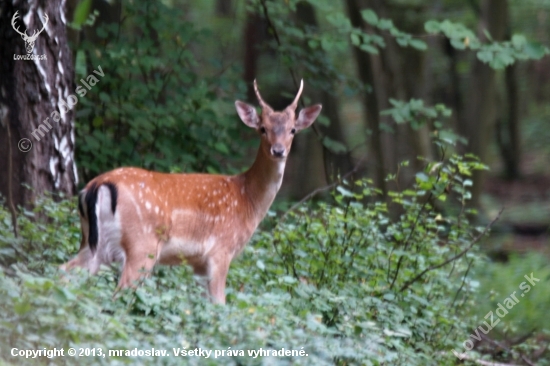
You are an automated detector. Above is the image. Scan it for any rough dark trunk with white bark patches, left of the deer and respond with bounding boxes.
[0,0,78,213]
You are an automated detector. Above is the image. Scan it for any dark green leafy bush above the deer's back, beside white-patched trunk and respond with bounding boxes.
[75,1,247,180]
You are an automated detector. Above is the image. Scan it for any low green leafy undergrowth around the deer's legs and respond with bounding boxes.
[0,155,500,365]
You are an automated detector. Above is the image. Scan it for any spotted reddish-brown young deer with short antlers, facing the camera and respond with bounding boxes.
[61,80,322,304]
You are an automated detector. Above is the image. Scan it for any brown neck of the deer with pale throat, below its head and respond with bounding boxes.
[242,145,286,223]
